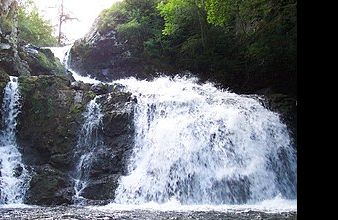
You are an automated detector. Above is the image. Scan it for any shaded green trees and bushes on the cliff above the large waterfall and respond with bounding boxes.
[93,0,297,95]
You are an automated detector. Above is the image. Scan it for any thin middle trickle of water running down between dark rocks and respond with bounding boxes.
[73,96,103,204]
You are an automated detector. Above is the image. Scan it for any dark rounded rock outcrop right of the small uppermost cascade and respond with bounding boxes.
[70,29,146,81]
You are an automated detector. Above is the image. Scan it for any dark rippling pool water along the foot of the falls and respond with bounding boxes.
[0,206,297,220]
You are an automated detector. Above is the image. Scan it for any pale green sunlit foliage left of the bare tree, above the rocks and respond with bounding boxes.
[18,3,57,46]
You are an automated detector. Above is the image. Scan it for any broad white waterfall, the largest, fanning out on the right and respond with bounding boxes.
[115,77,297,204]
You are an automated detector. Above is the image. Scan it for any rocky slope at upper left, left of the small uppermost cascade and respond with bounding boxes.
[0,0,66,78]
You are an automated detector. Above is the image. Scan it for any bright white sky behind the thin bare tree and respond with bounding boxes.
[30,0,120,40]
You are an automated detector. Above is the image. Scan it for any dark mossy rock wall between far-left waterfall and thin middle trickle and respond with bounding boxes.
[17,75,95,205]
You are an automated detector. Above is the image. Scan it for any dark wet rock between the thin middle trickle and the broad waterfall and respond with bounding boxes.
[73,90,134,204]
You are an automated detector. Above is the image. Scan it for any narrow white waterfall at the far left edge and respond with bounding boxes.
[0,76,30,204]
